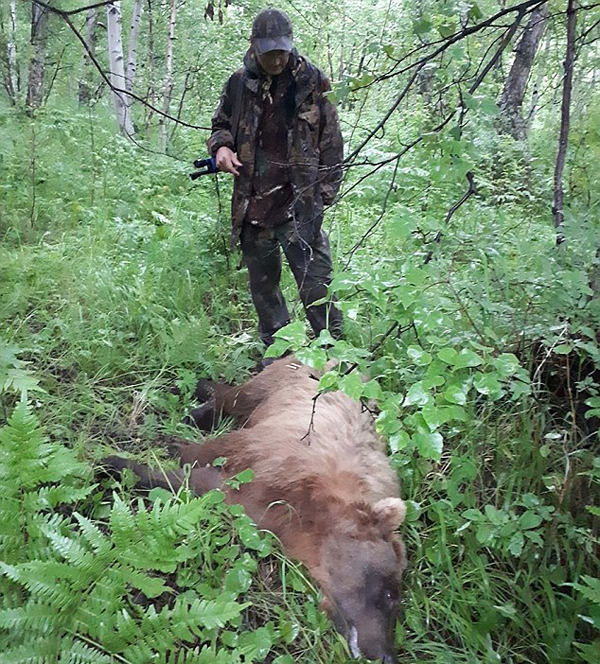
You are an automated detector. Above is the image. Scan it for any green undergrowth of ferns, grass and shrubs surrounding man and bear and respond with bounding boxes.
[0,24,600,664]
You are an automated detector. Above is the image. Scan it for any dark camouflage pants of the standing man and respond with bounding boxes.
[242,224,342,346]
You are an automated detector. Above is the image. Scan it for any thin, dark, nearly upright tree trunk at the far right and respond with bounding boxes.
[552,0,577,233]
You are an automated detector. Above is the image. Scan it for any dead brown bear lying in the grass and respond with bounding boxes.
[106,358,406,664]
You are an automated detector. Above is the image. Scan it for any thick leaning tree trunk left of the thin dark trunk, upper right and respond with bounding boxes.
[499,3,548,140]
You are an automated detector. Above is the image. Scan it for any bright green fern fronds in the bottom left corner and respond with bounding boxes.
[0,404,288,664]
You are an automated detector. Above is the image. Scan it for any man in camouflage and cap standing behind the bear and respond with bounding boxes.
[208,9,343,346]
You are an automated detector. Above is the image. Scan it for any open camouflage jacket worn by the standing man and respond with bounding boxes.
[208,48,343,245]
